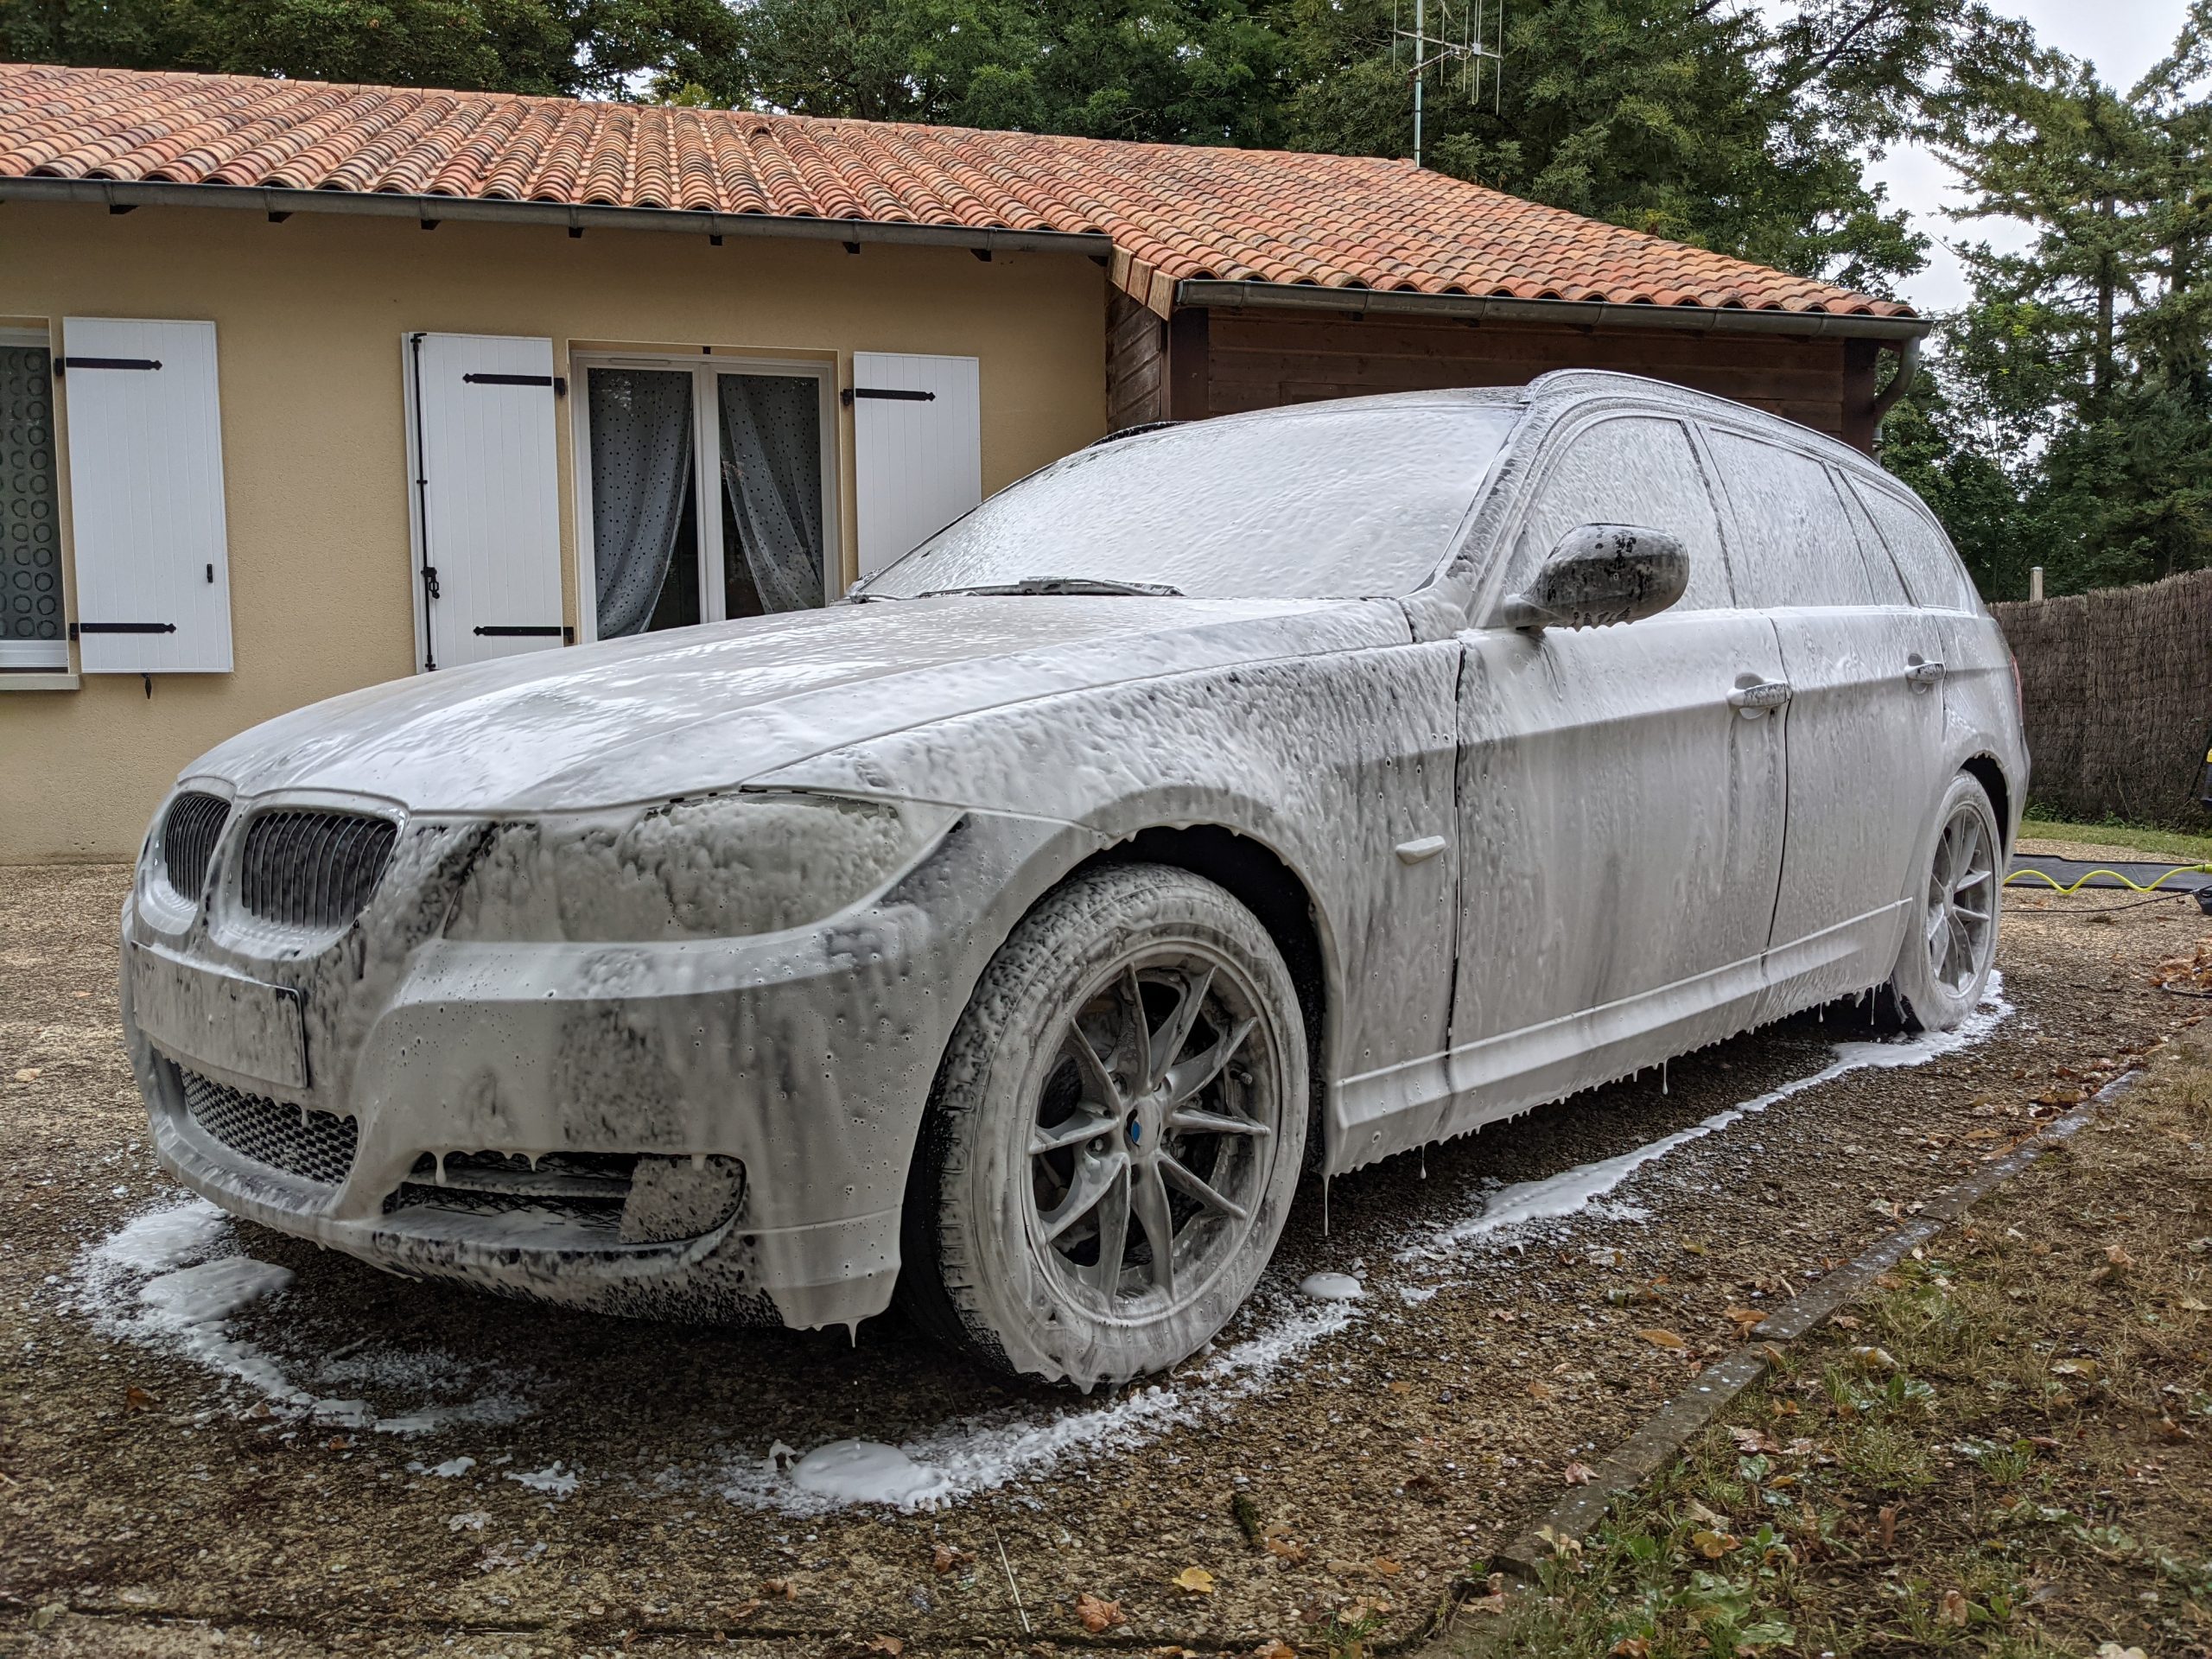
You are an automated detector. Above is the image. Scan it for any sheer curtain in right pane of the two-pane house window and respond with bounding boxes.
[716,374,823,611]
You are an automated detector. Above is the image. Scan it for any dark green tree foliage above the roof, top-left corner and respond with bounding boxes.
[0,0,736,98]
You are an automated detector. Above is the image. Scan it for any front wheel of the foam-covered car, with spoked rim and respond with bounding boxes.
[898,865,1307,1391]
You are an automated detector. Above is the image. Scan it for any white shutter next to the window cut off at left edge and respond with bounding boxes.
[62,316,230,675]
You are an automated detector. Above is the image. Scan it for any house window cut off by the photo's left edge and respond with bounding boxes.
[0,329,68,672]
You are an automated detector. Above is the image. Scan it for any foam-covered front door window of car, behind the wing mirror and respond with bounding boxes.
[1510,416,1734,611]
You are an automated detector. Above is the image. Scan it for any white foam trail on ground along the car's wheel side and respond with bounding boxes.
[721,973,2013,1516]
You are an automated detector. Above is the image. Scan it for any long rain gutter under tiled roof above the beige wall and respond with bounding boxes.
[0,177,1113,259]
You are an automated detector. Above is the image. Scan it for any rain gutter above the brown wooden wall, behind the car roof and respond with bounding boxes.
[1174,279,1933,340]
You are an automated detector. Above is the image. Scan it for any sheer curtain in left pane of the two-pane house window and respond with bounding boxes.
[591,370,692,639]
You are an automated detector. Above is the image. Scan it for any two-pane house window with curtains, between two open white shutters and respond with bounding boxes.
[577,356,841,639]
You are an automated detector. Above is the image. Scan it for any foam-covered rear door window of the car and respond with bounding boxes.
[1712,431,1876,611]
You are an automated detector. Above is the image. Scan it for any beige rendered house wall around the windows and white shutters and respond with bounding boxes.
[0,201,1106,862]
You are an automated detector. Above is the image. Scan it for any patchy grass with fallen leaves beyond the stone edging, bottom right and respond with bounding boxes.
[1453,1033,2212,1659]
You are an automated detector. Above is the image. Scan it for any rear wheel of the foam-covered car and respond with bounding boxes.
[1873,772,2004,1031]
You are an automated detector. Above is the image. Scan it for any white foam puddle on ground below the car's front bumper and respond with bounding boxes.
[71,1197,531,1433]
